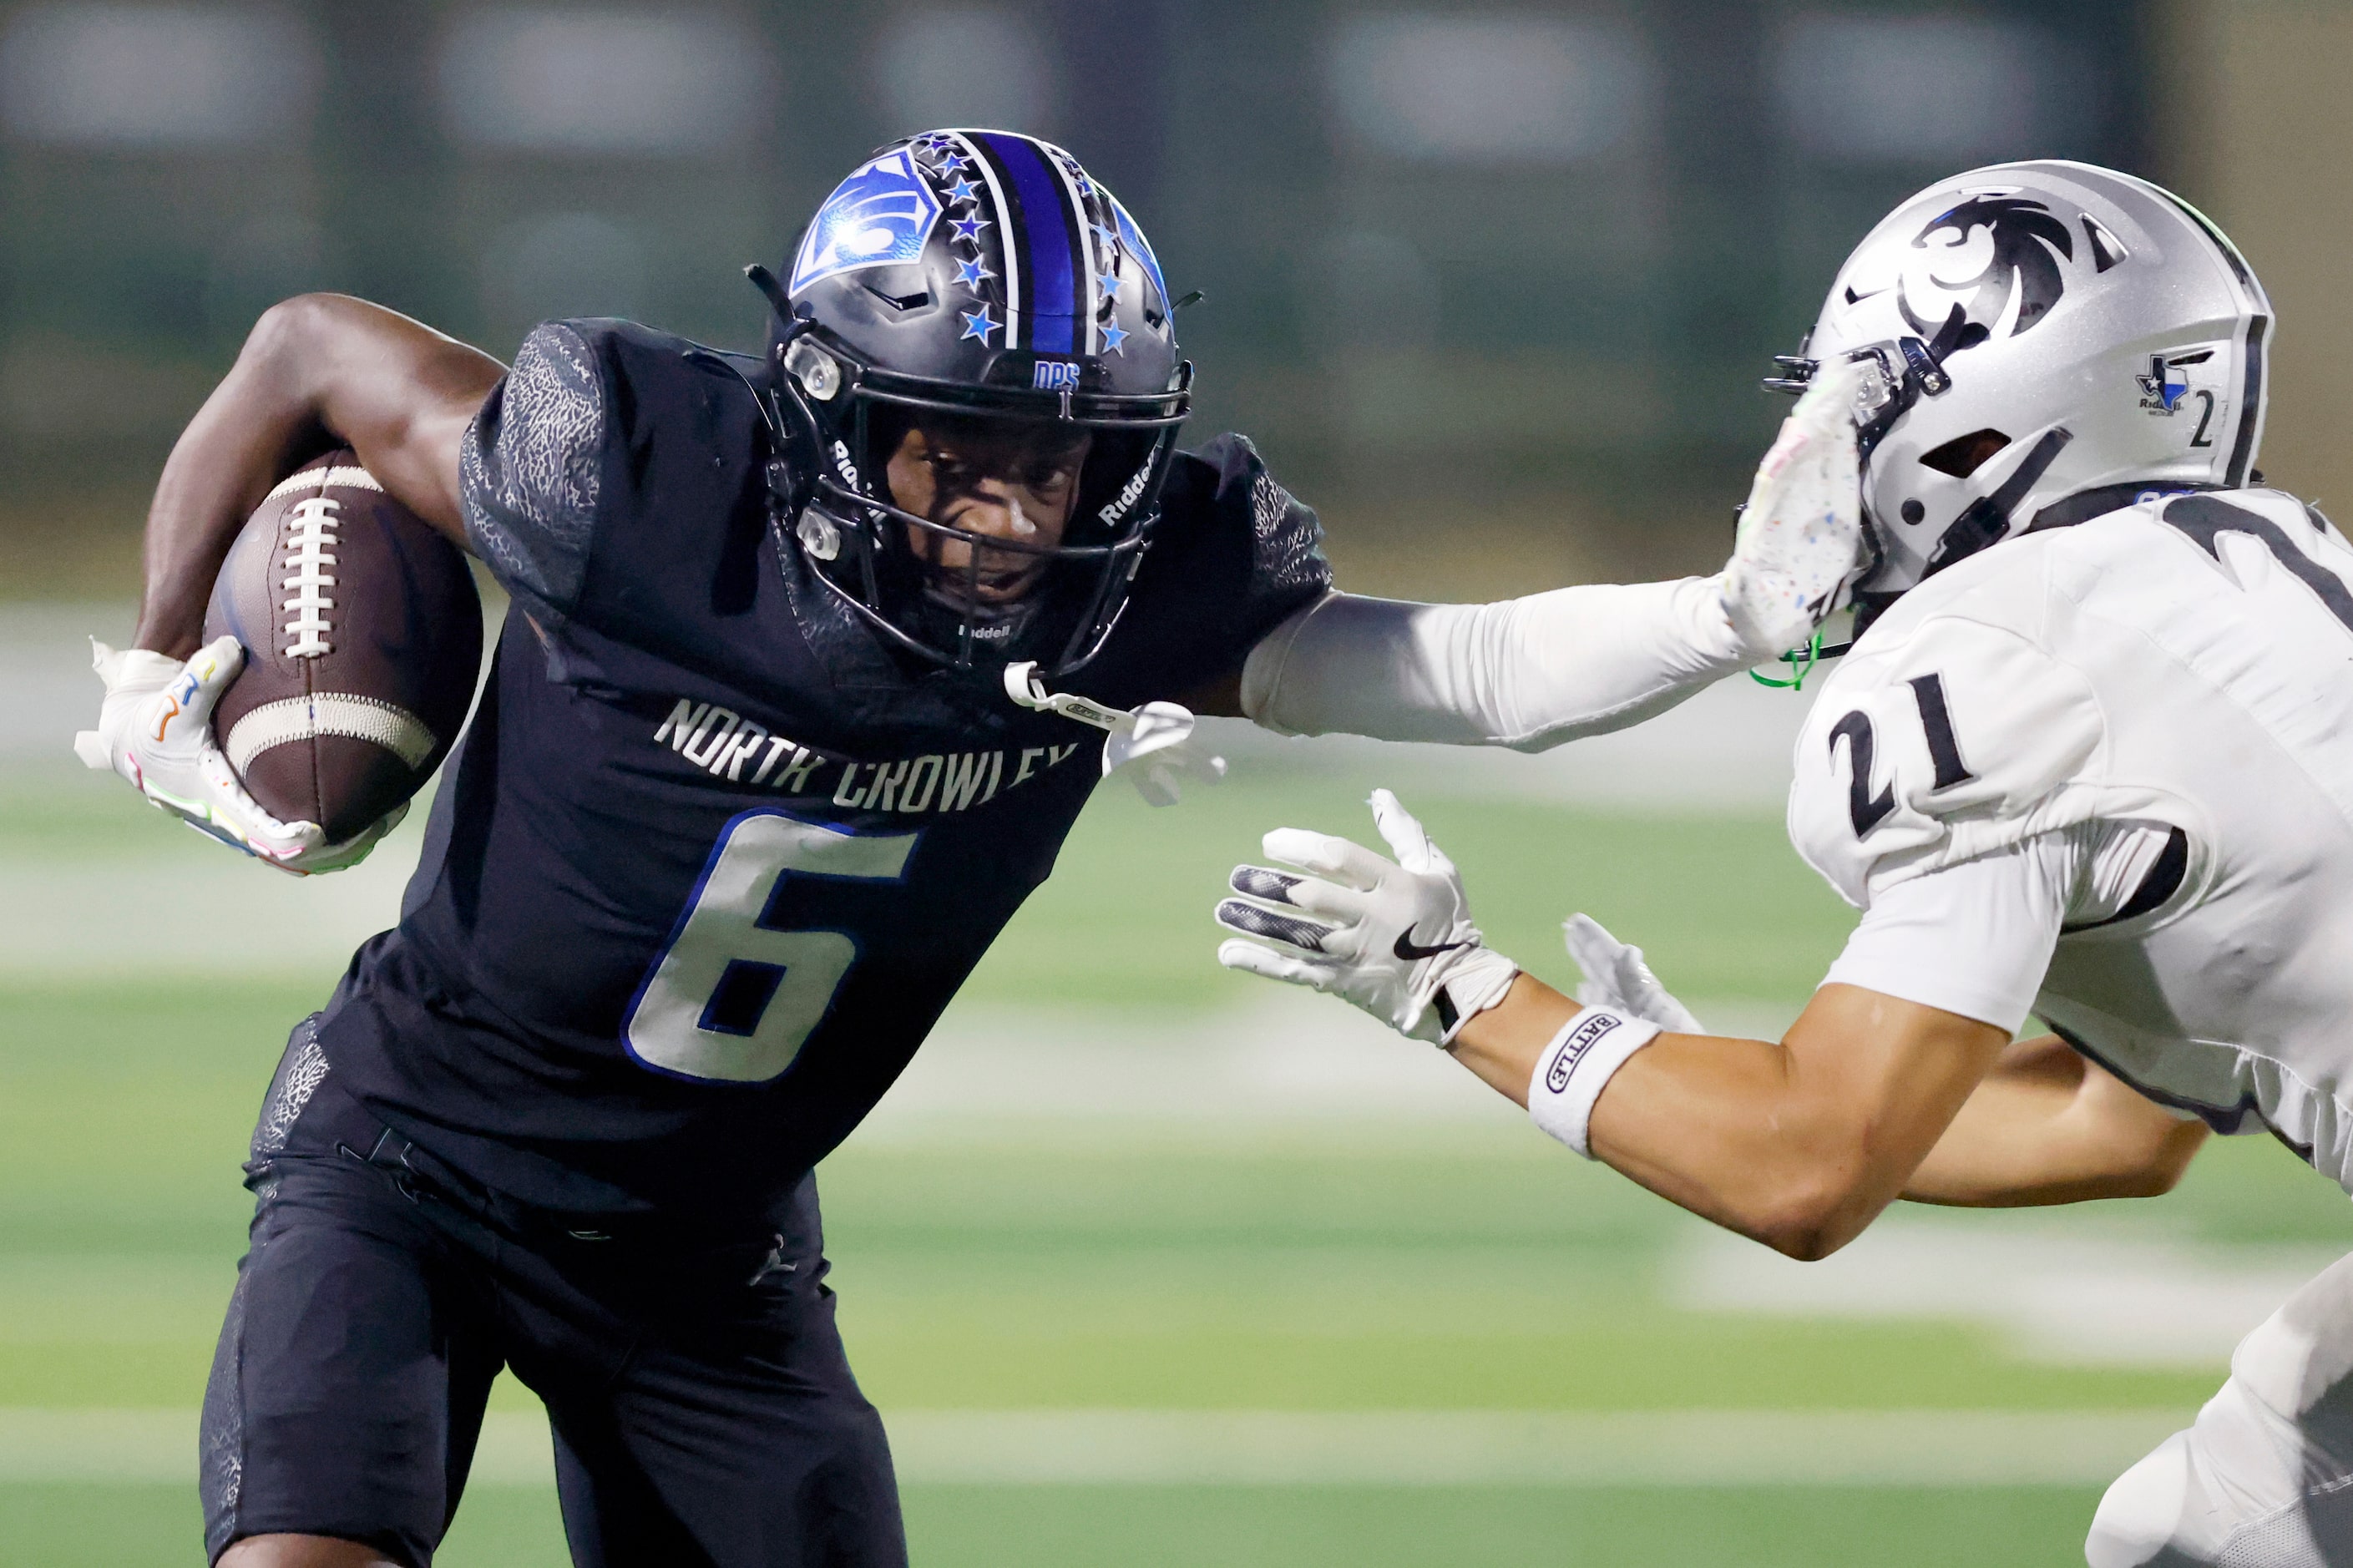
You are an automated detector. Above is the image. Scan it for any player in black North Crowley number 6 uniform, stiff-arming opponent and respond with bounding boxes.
[84,132,1855,1568]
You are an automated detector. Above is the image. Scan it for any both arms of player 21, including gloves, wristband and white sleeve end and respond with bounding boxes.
[1217,791,2204,1257]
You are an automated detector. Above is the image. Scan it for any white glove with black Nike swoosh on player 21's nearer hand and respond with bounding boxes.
[1217,789,1520,1045]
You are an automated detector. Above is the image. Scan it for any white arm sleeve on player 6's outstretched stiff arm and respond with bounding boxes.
[1242,577,1753,751]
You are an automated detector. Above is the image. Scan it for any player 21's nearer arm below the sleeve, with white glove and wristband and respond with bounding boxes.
[1217,791,2014,1257]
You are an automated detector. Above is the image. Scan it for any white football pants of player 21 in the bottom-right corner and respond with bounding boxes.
[2082,1257,2353,1568]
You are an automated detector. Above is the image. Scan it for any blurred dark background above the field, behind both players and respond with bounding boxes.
[0,0,2348,598]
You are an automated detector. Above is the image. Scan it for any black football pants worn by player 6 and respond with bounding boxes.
[200,1031,906,1568]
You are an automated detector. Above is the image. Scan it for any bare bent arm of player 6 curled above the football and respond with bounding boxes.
[136,294,506,660]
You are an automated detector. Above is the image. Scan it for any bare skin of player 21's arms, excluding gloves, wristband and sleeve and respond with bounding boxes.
[1455,974,2207,1257]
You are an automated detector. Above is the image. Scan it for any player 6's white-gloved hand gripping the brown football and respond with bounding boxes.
[73,638,402,876]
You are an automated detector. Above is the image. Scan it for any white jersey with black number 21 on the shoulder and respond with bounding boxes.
[1789,490,2353,1189]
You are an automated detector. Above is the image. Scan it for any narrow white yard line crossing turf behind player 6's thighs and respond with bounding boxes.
[0,1408,2189,1485]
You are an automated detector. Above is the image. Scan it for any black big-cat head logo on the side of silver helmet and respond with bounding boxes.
[1896,195,2075,353]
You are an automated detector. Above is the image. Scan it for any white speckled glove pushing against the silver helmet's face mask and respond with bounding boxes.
[1725,360,1866,660]
